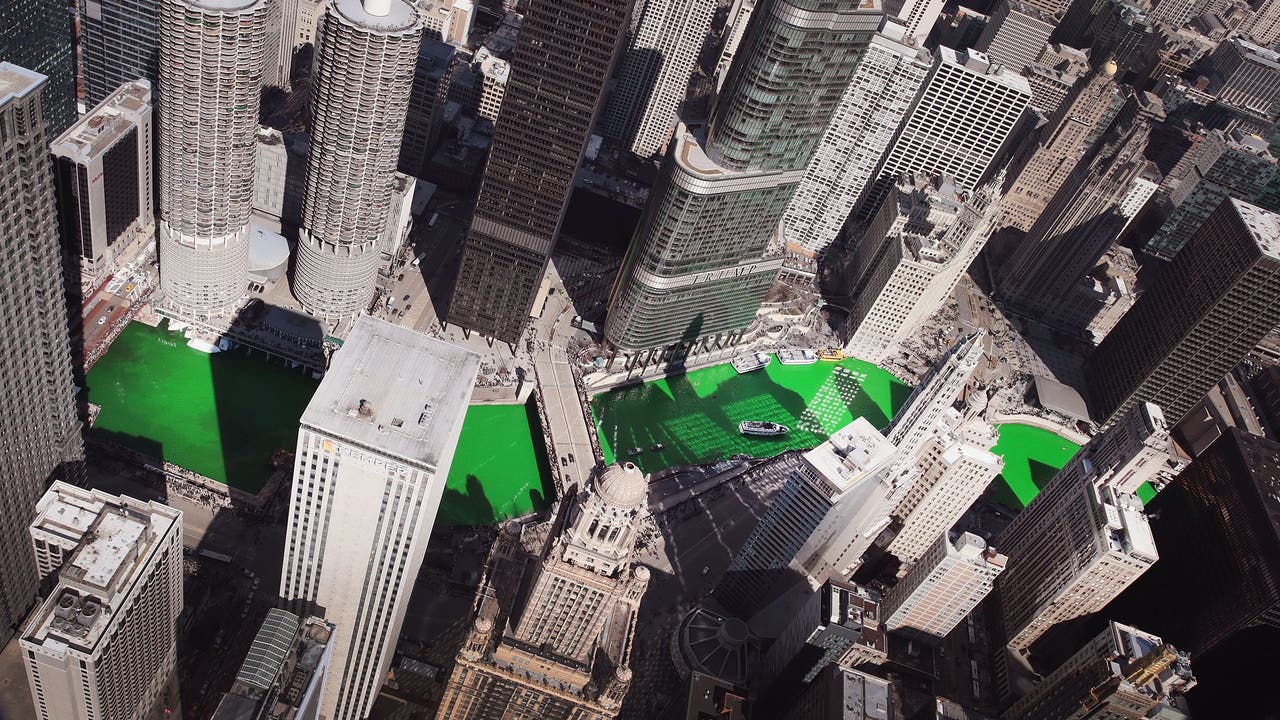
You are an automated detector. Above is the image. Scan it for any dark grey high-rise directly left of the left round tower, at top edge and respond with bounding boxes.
[79,0,160,108]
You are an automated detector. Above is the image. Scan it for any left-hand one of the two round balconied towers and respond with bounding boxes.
[160,0,274,318]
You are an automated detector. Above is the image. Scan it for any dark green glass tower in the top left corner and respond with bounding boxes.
[0,0,77,133]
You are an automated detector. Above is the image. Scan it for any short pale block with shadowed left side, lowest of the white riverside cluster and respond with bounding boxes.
[884,532,1009,643]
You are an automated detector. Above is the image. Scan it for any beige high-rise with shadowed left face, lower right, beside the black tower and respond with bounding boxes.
[996,457,1160,653]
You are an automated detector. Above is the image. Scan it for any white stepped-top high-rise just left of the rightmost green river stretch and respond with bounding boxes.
[888,410,1005,562]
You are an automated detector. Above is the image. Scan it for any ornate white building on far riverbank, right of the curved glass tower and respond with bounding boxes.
[845,174,1004,363]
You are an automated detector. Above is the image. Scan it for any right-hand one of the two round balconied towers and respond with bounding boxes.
[293,0,422,319]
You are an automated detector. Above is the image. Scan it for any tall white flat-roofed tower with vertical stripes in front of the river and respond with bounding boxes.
[280,316,480,720]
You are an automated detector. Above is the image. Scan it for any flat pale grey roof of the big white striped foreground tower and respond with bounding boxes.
[301,316,480,470]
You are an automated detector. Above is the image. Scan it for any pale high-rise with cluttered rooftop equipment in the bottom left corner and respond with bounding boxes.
[22,482,182,720]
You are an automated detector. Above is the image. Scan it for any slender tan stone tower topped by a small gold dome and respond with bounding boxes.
[998,61,1124,232]
